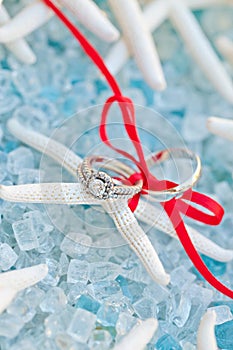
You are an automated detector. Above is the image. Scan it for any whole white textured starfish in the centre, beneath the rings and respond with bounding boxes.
[0,119,233,285]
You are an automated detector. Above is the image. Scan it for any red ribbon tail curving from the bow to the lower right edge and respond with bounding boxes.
[162,200,233,299]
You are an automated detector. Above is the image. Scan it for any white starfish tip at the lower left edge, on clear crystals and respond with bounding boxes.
[0,264,48,313]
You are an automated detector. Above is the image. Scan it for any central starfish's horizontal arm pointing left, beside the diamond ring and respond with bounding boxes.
[0,183,100,205]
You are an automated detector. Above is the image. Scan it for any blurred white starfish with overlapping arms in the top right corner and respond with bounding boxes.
[105,0,233,103]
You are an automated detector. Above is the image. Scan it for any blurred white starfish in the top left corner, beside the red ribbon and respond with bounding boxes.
[0,0,119,63]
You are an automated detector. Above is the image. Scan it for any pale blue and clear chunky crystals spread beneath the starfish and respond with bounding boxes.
[0,0,233,350]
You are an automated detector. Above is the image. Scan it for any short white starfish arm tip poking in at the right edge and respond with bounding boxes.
[207,117,233,141]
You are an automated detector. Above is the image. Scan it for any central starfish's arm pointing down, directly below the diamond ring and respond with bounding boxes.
[102,201,170,285]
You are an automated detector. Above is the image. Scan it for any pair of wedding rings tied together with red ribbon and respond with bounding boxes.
[77,148,201,201]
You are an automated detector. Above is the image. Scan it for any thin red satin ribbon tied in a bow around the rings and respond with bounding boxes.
[43,0,233,299]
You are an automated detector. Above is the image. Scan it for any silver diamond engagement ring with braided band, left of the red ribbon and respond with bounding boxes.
[77,156,143,199]
